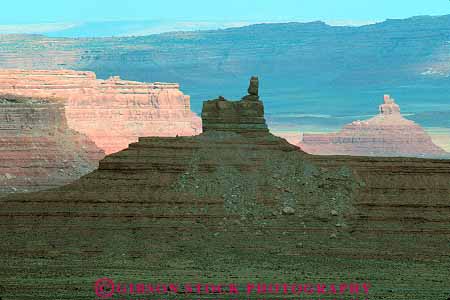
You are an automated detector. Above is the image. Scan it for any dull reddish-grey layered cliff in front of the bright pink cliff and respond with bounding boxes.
[0,95,104,195]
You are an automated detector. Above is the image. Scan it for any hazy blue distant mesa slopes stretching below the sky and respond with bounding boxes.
[0,15,450,118]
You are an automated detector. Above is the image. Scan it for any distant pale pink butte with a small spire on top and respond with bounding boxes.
[298,95,450,157]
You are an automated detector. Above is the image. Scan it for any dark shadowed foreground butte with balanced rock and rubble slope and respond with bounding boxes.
[0,78,450,300]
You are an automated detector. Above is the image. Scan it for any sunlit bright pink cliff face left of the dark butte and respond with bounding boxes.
[0,70,202,154]
